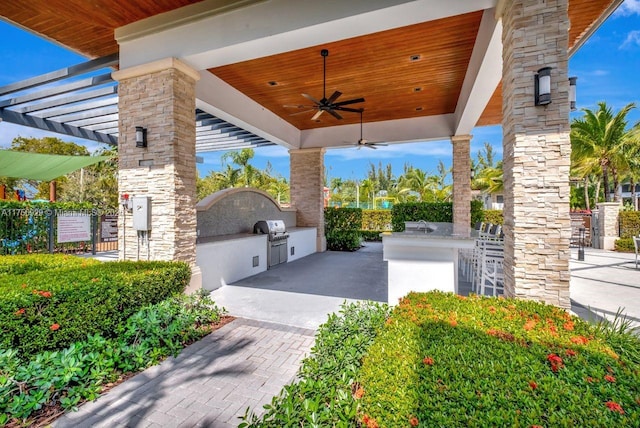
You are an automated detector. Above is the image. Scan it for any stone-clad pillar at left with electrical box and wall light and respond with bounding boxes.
[113,58,199,290]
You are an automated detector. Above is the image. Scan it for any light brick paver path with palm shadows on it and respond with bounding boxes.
[53,319,315,428]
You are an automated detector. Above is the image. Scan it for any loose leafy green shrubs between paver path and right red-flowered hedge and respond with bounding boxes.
[240,302,389,428]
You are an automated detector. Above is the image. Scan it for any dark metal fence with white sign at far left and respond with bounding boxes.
[0,207,118,255]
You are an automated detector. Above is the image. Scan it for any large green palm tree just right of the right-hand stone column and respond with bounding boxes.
[571,102,635,201]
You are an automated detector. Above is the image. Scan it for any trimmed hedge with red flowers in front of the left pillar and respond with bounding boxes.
[0,255,191,358]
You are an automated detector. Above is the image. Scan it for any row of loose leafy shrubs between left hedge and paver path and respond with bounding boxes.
[0,295,224,426]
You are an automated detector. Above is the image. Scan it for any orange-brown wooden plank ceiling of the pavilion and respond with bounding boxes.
[0,0,612,129]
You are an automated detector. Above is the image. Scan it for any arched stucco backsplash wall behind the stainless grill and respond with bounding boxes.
[196,187,296,238]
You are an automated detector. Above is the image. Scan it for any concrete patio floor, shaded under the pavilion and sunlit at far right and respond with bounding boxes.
[211,242,640,328]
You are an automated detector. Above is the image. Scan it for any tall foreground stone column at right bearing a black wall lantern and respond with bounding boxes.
[502,0,571,308]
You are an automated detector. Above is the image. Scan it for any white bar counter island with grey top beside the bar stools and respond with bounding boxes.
[382,232,474,305]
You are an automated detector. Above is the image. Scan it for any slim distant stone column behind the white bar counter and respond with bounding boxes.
[451,135,471,233]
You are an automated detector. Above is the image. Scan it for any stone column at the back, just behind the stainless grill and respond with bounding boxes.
[289,148,327,251]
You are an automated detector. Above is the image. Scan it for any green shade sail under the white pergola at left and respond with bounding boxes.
[0,150,114,181]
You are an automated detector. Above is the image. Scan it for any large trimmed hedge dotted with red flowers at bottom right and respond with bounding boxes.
[357,292,640,427]
